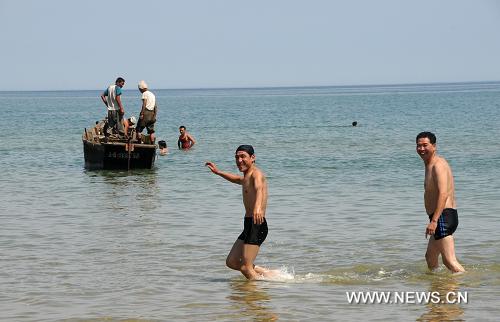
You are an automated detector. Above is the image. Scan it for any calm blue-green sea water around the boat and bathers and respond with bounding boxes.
[0,83,500,321]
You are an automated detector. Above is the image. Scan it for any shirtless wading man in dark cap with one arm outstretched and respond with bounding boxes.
[205,145,273,280]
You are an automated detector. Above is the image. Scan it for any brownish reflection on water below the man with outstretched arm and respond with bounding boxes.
[228,279,279,321]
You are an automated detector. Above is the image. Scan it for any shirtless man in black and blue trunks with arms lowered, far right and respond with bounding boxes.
[416,132,465,273]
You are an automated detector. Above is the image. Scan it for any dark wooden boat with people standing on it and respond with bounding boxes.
[82,121,157,170]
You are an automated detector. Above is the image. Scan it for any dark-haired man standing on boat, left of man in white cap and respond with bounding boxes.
[101,77,125,133]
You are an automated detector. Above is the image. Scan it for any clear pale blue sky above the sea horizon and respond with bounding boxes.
[0,0,500,91]
